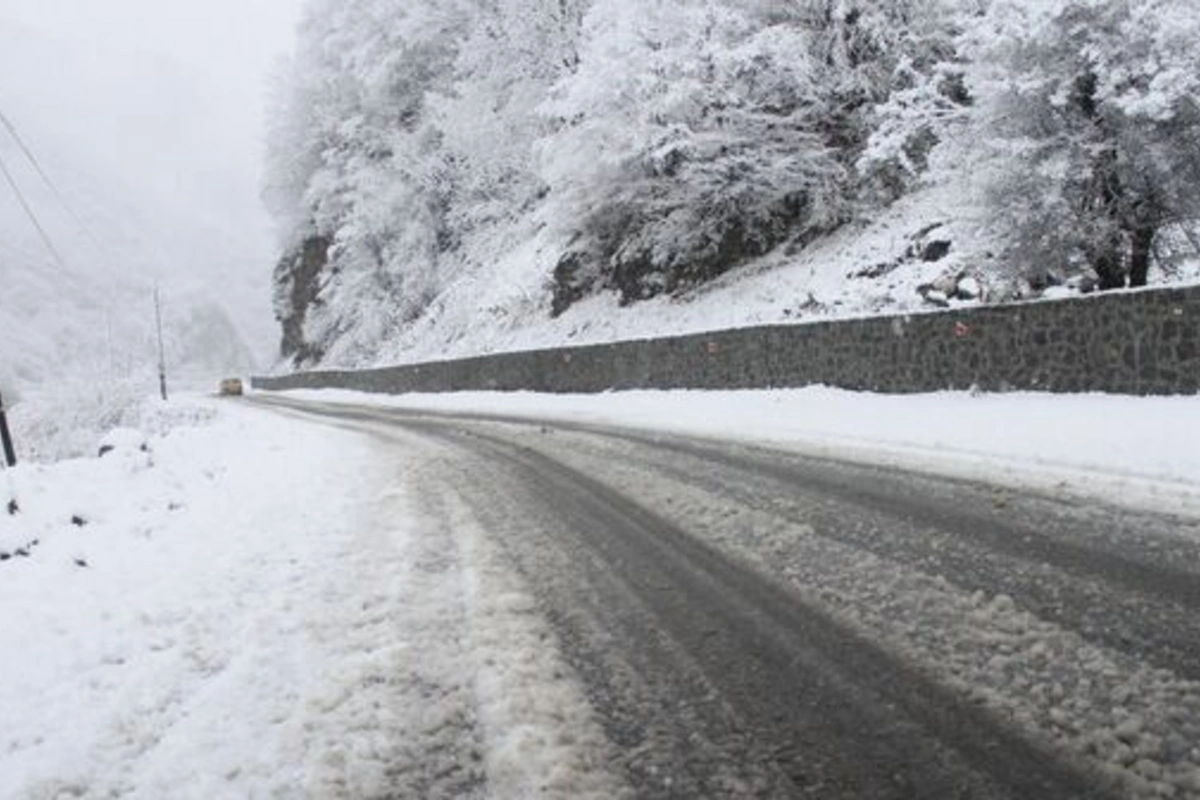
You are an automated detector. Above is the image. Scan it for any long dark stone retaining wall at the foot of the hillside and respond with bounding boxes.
[252,287,1200,395]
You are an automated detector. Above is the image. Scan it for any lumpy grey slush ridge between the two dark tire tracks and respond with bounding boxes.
[494,422,1200,796]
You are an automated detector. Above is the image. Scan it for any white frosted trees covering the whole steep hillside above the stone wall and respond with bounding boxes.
[266,0,1200,365]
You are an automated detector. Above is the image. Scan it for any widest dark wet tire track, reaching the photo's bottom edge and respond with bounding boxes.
[391,425,1106,799]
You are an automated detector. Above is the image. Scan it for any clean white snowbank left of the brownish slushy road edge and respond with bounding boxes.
[0,404,386,798]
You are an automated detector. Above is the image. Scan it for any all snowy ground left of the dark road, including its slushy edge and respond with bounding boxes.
[0,399,620,799]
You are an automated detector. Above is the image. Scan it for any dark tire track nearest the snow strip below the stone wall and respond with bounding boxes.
[552,424,1200,680]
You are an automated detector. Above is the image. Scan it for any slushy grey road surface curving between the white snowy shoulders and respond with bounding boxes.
[259,398,1200,798]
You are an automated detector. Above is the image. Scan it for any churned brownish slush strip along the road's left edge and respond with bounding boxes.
[322,431,629,800]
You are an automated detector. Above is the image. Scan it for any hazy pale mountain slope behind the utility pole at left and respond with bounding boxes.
[0,22,272,400]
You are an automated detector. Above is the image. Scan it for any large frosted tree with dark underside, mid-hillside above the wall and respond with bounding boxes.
[540,0,845,311]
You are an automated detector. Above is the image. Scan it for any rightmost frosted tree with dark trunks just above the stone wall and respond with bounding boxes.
[976,0,1200,288]
